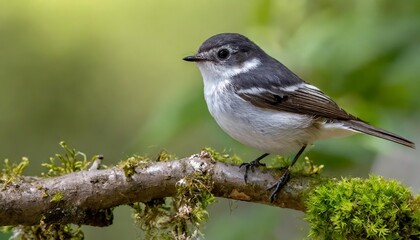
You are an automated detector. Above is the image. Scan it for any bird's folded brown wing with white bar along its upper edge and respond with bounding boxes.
[236,82,361,121]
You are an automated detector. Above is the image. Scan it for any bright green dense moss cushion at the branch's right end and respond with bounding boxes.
[306,175,420,239]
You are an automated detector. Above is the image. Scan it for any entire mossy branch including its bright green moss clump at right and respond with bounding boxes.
[0,142,420,239]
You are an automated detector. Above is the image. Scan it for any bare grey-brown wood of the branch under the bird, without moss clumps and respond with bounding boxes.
[0,155,320,226]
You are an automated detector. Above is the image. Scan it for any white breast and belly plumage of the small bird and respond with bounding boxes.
[204,80,317,154]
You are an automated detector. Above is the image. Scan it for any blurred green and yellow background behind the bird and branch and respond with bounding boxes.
[0,0,420,240]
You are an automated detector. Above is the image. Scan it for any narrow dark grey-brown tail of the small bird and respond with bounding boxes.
[344,120,416,148]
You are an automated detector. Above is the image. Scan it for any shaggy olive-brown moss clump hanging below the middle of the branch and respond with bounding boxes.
[132,158,215,239]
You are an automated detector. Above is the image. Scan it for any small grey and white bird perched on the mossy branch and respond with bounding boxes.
[183,33,415,202]
